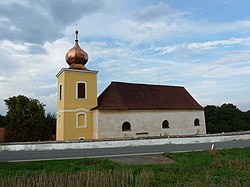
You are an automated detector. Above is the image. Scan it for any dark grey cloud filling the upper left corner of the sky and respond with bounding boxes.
[0,0,103,44]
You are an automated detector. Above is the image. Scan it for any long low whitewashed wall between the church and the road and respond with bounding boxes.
[0,133,250,151]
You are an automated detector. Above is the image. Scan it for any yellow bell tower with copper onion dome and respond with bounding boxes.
[56,30,98,140]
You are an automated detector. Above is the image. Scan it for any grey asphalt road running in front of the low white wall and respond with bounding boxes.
[0,140,250,162]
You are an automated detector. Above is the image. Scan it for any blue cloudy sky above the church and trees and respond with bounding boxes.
[0,0,250,115]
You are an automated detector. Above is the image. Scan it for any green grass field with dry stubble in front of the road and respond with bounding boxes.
[0,147,250,187]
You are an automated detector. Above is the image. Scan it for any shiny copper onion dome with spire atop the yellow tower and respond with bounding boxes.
[65,30,88,70]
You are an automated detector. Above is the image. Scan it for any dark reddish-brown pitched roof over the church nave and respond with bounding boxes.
[97,82,203,110]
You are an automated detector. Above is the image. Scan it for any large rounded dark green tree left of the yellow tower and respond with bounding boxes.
[4,95,50,141]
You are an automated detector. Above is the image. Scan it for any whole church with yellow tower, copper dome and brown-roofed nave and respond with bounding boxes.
[56,31,206,140]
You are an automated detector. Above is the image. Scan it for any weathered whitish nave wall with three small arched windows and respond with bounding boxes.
[95,110,206,138]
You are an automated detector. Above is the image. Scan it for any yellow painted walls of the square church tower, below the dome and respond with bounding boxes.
[56,69,97,140]
